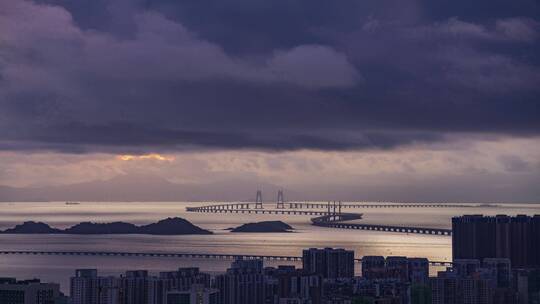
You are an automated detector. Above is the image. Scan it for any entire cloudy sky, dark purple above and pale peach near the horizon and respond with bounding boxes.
[0,0,540,202]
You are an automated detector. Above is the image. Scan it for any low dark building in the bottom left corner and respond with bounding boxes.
[0,278,63,304]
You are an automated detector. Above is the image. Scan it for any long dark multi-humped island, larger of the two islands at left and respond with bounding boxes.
[0,217,212,235]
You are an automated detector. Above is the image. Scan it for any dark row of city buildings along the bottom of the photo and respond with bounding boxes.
[0,242,540,304]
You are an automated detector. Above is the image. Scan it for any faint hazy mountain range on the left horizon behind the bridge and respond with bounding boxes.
[0,175,298,202]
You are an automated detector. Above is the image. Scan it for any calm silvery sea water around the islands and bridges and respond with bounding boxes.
[0,202,540,290]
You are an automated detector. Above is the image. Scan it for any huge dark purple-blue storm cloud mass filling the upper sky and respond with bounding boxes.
[0,0,540,152]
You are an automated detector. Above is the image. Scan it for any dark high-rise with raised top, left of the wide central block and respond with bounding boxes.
[215,259,265,304]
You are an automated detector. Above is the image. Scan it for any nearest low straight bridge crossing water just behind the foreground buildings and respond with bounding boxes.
[0,250,452,266]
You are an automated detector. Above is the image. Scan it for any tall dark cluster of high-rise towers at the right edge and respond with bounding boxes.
[452,215,540,268]
